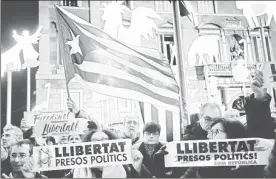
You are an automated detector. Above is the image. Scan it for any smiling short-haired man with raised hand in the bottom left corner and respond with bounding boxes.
[2,139,47,178]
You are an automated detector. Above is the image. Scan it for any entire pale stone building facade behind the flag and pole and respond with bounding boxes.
[36,0,276,140]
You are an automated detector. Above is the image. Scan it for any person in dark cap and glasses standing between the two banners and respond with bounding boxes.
[134,122,163,177]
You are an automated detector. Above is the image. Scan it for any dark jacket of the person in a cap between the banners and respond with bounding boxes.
[138,142,163,177]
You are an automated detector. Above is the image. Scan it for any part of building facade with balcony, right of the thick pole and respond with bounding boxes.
[182,1,276,114]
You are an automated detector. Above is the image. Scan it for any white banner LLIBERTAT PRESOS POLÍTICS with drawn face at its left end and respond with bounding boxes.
[33,139,132,171]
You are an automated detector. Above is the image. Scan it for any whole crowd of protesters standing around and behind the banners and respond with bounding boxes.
[1,72,276,178]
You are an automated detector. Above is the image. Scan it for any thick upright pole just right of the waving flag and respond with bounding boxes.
[171,0,189,128]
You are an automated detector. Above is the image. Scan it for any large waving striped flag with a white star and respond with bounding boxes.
[56,6,179,112]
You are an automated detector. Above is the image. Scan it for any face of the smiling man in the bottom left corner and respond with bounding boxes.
[10,144,31,172]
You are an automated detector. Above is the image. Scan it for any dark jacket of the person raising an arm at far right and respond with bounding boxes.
[244,94,275,139]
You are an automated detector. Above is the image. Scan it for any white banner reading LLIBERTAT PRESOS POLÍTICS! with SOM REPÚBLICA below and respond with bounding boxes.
[165,138,273,167]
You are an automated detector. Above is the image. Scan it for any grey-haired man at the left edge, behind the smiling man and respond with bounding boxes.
[1,125,23,174]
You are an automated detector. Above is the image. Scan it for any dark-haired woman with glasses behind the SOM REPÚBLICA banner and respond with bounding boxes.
[182,118,263,178]
